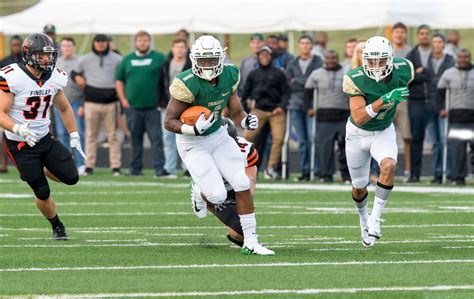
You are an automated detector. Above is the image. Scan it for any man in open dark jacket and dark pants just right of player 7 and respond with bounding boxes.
[406,25,433,183]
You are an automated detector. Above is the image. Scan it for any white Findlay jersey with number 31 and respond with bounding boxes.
[0,63,68,141]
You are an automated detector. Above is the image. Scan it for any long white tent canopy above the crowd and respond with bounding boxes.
[0,0,474,34]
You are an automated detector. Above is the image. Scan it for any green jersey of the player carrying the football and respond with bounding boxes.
[170,64,240,135]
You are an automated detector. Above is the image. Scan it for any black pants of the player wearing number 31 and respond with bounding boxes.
[6,134,78,190]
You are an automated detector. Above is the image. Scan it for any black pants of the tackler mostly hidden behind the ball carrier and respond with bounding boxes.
[208,190,244,236]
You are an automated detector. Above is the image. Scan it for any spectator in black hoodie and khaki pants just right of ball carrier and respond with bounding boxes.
[242,46,290,179]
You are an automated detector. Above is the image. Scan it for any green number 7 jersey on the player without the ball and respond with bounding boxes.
[343,58,415,131]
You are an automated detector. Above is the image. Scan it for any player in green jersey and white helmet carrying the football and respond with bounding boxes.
[165,35,275,255]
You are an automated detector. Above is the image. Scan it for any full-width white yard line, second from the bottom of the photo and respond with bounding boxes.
[0,259,474,272]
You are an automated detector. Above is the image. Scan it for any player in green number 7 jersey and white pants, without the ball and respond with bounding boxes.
[343,36,414,247]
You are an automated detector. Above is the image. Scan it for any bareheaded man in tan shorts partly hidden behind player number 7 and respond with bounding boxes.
[392,22,412,182]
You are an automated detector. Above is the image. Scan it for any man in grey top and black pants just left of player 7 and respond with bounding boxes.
[305,50,350,183]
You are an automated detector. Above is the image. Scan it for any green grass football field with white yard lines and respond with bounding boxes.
[0,170,474,298]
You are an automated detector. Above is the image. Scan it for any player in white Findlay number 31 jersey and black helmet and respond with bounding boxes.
[0,33,85,240]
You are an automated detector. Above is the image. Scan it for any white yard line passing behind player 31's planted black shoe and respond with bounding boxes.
[0,223,474,233]
